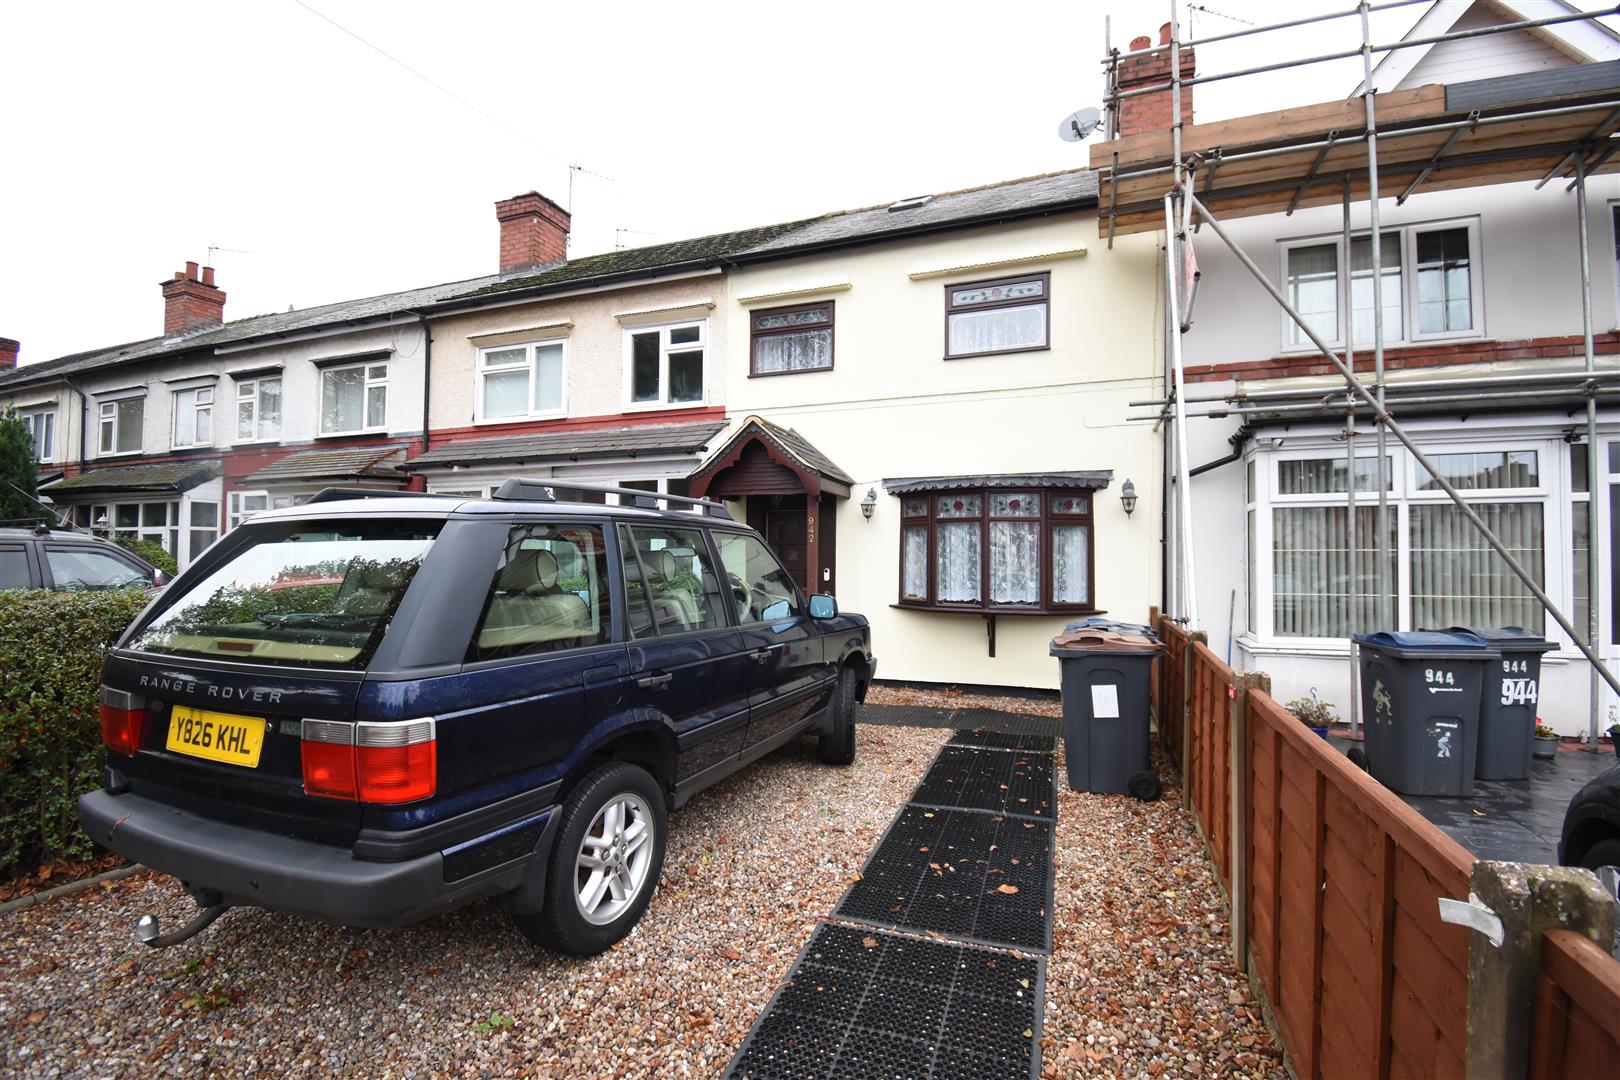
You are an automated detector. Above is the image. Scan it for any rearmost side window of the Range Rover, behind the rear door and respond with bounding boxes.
[467,523,612,662]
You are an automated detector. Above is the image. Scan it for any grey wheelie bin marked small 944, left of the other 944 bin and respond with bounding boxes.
[1356,630,1500,795]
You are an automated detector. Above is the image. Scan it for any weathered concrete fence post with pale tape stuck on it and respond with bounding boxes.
[1464,861,1615,1080]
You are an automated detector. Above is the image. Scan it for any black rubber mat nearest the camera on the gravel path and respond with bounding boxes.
[727,923,1045,1080]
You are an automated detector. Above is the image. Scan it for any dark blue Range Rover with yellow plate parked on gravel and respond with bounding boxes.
[79,479,873,955]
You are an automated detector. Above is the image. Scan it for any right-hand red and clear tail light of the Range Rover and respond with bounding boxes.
[300,717,439,803]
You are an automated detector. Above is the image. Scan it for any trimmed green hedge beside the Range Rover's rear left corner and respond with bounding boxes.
[0,589,147,878]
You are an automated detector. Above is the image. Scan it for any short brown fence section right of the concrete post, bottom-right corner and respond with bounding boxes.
[1529,929,1620,1080]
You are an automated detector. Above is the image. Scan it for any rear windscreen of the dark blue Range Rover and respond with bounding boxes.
[128,521,441,669]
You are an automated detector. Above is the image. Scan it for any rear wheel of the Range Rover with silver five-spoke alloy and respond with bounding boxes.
[512,761,669,957]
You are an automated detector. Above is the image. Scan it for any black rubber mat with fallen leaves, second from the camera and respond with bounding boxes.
[834,803,1053,952]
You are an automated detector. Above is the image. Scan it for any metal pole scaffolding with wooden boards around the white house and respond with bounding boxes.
[1092,0,1620,750]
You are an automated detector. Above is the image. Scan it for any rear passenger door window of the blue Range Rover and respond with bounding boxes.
[620,525,726,638]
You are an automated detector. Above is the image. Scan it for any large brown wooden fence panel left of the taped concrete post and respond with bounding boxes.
[1244,687,1473,1077]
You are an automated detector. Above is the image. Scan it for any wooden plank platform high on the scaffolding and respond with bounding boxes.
[1090,60,1620,236]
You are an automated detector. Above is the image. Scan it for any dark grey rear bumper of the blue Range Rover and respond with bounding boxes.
[79,790,559,926]
